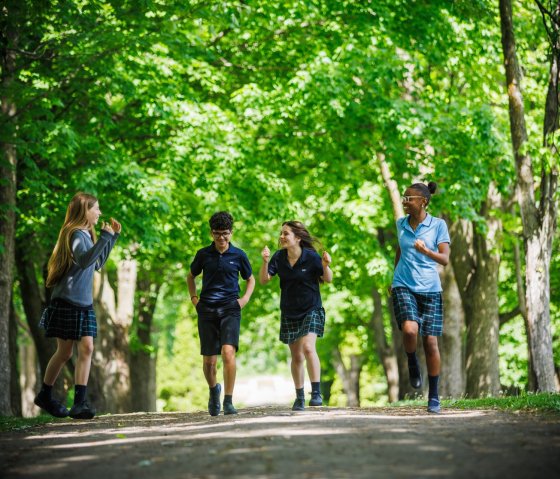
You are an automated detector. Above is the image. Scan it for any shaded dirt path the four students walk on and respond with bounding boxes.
[0,407,560,479]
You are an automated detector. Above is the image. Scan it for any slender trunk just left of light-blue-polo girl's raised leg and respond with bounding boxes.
[370,288,399,402]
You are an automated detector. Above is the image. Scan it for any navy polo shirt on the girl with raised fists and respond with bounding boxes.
[268,248,323,318]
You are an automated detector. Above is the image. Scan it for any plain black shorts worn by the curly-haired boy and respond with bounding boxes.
[196,300,241,356]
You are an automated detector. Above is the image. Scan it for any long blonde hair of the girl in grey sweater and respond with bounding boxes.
[46,193,97,288]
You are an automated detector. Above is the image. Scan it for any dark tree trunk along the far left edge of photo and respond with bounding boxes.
[0,17,17,416]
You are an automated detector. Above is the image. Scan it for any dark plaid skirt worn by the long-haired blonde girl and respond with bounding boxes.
[39,299,97,341]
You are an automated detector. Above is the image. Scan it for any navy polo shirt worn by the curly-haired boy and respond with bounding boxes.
[191,243,253,304]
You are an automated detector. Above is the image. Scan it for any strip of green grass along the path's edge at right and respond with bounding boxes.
[393,393,560,415]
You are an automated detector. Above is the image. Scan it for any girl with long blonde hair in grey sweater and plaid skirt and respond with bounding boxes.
[35,193,121,419]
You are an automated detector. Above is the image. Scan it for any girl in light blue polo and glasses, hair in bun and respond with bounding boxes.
[391,182,451,413]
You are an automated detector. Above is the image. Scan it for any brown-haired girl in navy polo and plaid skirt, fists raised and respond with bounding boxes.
[259,221,333,411]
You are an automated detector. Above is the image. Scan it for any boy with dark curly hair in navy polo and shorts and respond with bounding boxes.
[187,211,255,416]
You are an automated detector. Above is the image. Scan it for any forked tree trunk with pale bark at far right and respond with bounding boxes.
[500,0,558,392]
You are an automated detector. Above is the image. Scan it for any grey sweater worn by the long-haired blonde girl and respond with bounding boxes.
[51,230,119,307]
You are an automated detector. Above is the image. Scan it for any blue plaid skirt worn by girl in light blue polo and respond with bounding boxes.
[391,287,443,336]
